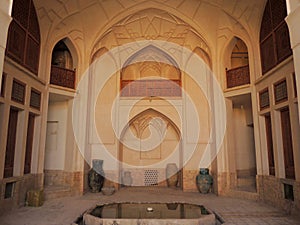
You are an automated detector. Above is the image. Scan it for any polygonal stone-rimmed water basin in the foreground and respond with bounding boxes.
[74,203,216,225]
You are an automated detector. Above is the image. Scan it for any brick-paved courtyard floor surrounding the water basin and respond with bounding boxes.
[0,188,300,225]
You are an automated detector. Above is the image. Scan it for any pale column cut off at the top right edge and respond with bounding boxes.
[286,0,300,124]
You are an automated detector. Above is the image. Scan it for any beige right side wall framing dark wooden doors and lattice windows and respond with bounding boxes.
[256,57,300,212]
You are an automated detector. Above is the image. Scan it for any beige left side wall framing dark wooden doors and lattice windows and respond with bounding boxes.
[0,57,47,212]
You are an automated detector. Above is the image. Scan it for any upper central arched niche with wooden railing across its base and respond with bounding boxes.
[120,45,181,97]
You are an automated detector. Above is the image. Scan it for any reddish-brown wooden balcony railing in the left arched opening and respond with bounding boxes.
[50,65,75,89]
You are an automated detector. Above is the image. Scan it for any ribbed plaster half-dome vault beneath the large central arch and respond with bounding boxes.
[93,8,210,62]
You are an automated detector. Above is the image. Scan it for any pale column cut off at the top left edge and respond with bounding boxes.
[0,0,12,90]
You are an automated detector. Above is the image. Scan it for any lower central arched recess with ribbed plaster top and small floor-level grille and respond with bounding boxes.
[119,109,182,188]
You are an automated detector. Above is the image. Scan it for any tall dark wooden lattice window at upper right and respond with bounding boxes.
[260,0,292,74]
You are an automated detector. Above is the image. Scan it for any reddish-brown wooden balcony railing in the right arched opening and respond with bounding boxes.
[226,65,250,88]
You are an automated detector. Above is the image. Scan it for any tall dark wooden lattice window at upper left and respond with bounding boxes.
[6,0,40,75]
